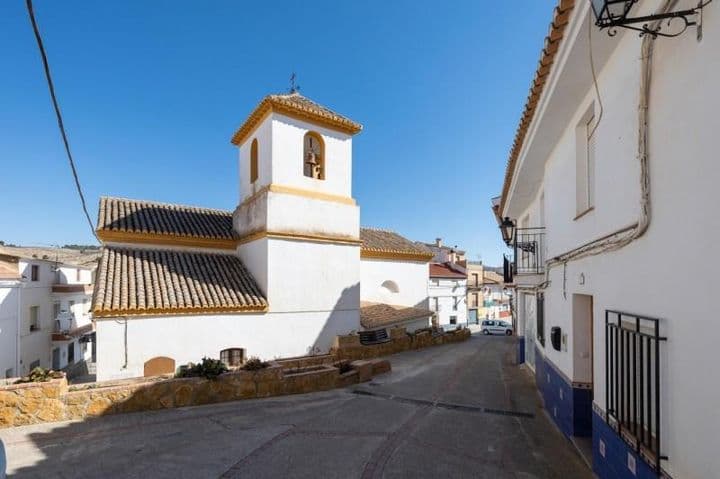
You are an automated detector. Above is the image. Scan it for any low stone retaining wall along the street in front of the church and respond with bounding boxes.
[0,328,470,428]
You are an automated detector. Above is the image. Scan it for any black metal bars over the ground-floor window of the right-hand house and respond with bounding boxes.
[605,310,667,473]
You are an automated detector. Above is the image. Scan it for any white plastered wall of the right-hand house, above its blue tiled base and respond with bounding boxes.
[502,1,720,477]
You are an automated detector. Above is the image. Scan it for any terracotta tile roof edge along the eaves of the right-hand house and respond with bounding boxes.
[493,0,575,214]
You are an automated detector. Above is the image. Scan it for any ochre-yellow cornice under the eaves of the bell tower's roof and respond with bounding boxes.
[230,97,362,146]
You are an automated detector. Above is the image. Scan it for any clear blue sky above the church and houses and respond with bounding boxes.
[0,0,556,265]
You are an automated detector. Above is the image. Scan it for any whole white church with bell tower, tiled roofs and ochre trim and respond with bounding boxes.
[92,92,433,380]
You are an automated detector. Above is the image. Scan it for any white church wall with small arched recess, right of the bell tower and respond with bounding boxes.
[360,258,428,308]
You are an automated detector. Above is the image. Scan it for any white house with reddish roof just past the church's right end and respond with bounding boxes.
[428,263,468,329]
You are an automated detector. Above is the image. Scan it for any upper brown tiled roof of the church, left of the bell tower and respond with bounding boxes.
[97,196,236,240]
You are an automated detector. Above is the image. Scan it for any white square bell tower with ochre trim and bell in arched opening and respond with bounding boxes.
[232,92,362,346]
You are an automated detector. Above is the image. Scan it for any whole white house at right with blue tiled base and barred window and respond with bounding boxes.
[497,0,720,478]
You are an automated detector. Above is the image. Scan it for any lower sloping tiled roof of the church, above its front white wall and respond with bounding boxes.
[93,247,267,317]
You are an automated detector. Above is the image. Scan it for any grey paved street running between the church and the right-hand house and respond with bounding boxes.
[0,335,592,479]
